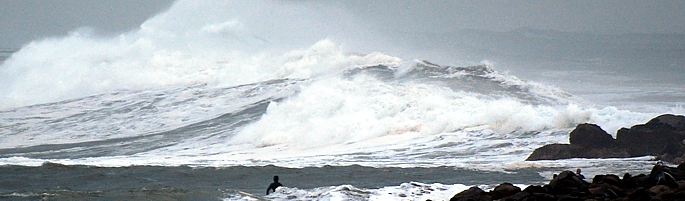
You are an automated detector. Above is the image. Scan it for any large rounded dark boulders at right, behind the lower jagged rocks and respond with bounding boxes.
[526,114,685,164]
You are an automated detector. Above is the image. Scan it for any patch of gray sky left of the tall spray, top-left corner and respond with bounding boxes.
[0,0,173,48]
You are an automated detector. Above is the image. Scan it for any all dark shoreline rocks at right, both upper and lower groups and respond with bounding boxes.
[450,114,685,201]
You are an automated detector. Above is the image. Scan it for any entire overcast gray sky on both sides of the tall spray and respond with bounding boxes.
[0,0,685,48]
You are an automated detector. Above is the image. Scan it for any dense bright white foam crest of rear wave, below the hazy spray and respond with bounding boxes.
[0,35,401,109]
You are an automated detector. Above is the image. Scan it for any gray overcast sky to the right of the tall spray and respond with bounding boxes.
[340,0,685,34]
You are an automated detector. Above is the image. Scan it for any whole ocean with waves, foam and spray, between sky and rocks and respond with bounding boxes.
[0,1,685,200]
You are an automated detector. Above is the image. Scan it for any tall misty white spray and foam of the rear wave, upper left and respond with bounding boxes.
[0,1,392,109]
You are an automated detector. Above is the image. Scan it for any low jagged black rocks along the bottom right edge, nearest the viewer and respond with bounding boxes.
[450,162,685,201]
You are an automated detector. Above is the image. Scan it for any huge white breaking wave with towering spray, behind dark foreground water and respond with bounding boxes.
[0,0,664,169]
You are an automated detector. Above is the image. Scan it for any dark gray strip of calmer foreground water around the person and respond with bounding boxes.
[0,163,544,200]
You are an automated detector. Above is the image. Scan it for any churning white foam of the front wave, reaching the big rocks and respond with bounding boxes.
[0,73,664,171]
